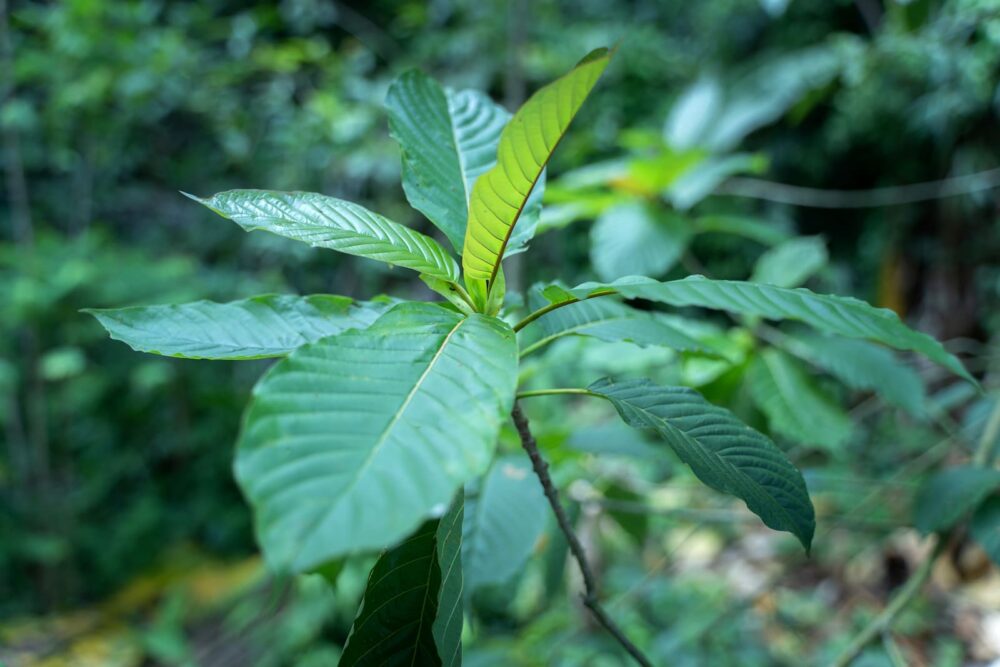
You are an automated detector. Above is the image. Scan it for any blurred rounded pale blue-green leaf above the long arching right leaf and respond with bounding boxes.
[590,202,691,280]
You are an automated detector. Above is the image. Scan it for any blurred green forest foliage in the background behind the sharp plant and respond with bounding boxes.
[0,0,1000,666]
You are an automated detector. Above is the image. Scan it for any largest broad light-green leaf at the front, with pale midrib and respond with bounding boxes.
[236,303,517,571]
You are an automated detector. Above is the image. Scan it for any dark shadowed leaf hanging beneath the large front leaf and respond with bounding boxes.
[339,497,462,667]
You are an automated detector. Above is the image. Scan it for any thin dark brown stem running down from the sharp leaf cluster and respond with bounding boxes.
[511,402,653,667]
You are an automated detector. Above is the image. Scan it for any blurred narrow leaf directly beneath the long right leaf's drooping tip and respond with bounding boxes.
[782,333,927,415]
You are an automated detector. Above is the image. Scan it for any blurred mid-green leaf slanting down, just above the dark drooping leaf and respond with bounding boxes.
[747,349,852,449]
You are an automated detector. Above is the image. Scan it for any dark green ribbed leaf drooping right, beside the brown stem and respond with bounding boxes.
[588,378,816,551]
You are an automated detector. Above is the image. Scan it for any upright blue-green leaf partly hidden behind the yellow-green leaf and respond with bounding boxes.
[386,70,542,254]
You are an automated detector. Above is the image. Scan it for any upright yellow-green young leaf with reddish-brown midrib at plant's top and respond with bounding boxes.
[462,49,611,283]
